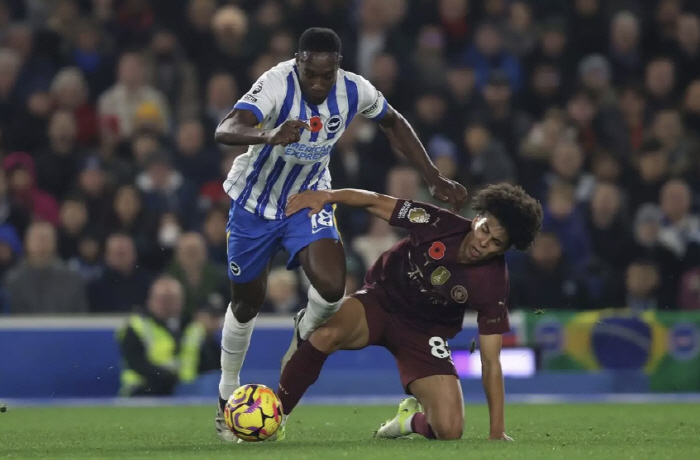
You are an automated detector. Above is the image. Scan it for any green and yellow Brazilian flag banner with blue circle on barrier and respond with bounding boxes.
[526,309,700,392]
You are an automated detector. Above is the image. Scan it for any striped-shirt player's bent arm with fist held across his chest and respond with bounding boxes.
[214,109,311,145]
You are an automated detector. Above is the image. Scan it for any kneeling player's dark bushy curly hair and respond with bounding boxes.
[472,183,542,251]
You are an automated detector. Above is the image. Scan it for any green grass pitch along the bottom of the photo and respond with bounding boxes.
[0,404,700,460]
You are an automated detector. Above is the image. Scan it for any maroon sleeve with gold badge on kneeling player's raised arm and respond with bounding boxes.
[389,200,471,241]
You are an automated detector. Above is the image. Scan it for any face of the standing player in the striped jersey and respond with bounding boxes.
[297,52,340,104]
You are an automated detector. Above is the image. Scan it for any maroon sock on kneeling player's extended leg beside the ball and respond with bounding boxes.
[277,340,328,415]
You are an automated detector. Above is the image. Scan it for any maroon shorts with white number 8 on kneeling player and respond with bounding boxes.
[351,287,457,394]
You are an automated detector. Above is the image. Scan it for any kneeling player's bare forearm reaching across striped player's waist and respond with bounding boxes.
[285,188,398,222]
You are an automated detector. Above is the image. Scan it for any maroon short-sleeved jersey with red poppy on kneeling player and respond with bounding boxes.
[365,200,510,338]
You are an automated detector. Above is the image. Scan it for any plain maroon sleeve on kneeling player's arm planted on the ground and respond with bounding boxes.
[470,262,510,335]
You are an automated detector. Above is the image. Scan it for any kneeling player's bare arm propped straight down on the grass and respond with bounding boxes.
[479,334,512,441]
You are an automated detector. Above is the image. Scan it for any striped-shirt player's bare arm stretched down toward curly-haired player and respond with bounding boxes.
[379,106,467,212]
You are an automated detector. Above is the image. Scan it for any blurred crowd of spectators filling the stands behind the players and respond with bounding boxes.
[0,0,700,318]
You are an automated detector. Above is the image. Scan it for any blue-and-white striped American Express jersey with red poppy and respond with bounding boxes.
[224,60,388,219]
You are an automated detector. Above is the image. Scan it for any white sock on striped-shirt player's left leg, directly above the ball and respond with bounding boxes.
[219,304,255,399]
